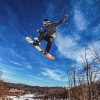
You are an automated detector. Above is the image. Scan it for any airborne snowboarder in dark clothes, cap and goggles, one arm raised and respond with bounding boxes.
[34,14,68,53]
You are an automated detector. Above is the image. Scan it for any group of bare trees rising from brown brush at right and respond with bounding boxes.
[67,44,100,100]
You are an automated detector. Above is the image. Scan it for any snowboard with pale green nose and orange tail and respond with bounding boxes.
[26,37,55,60]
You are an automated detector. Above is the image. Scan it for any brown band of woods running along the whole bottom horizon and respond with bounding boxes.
[0,81,100,100]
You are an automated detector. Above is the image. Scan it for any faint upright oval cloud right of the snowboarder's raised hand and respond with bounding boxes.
[74,9,87,31]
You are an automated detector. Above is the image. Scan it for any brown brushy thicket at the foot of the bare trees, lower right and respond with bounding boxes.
[68,81,100,100]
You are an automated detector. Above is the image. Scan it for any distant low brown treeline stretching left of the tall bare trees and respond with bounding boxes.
[0,81,67,100]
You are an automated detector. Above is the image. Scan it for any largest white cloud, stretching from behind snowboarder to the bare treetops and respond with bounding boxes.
[55,32,100,63]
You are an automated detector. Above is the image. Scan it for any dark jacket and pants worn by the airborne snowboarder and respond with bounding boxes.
[38,16,66,52]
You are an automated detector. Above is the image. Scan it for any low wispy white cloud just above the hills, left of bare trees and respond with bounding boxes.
[42,68,67,81]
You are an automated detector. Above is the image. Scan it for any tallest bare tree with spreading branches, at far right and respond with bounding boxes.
[81,44,100,100]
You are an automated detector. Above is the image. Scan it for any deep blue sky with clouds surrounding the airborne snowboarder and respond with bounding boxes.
[0,0,100,86]
